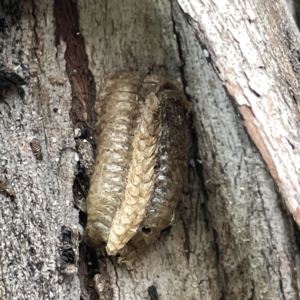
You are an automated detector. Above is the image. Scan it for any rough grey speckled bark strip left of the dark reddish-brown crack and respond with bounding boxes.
[0,1,80,299]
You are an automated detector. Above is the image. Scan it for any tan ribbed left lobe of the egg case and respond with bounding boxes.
[86,73,143,247]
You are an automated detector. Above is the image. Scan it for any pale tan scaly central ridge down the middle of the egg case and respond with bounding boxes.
[106,93,161,255]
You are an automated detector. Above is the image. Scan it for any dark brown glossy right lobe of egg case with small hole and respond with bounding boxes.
[131,83,187,251]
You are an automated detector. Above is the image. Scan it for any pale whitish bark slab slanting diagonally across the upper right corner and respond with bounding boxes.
[179,1,300,225]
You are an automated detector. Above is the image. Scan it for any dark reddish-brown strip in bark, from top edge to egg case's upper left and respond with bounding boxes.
[54,0,96,132]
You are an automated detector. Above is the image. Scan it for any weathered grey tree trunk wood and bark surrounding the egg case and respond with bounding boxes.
[0,0,300,300]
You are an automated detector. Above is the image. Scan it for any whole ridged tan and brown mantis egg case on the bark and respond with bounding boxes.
[86,73,189,261]
